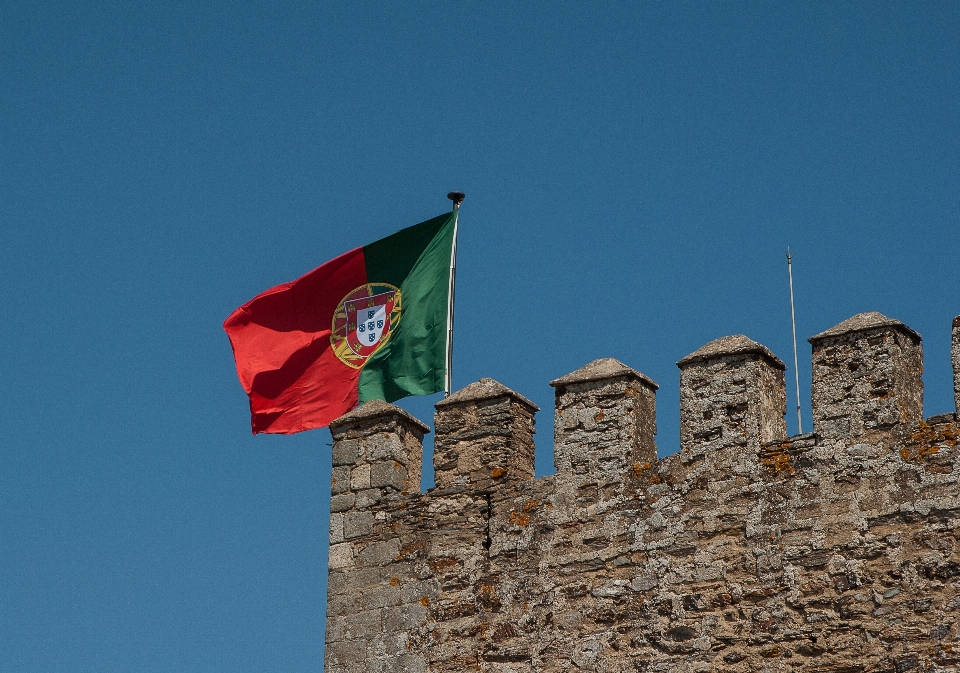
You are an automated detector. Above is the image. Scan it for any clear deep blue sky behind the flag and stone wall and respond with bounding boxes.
[0,0,960,673]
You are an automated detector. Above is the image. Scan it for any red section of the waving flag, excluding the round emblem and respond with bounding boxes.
[223,248,367,434]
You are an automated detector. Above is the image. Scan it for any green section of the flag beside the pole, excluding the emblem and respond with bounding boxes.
[359,211,457,403]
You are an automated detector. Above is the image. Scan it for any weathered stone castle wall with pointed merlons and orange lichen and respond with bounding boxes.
[325,313,960,673]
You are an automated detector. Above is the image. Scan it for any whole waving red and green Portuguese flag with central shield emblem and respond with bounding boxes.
[229,209,457,434]
